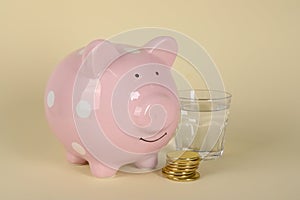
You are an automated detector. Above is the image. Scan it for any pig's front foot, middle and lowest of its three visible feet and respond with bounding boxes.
[89,160,117,178]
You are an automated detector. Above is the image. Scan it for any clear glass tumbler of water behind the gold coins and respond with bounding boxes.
[175,89,231,160]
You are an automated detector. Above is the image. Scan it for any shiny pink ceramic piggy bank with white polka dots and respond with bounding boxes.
[45,36,180,177]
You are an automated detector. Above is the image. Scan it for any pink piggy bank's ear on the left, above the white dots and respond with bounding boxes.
[81,40,119,78]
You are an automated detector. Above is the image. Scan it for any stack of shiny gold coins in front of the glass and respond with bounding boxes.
[162,151,200,182]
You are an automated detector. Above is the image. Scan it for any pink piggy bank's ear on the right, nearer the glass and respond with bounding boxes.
[143,36,178,66]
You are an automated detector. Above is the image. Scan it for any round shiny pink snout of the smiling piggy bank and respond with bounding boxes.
[129,85,179,136]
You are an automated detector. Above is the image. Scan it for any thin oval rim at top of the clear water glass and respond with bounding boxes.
[178,89,232,101]
